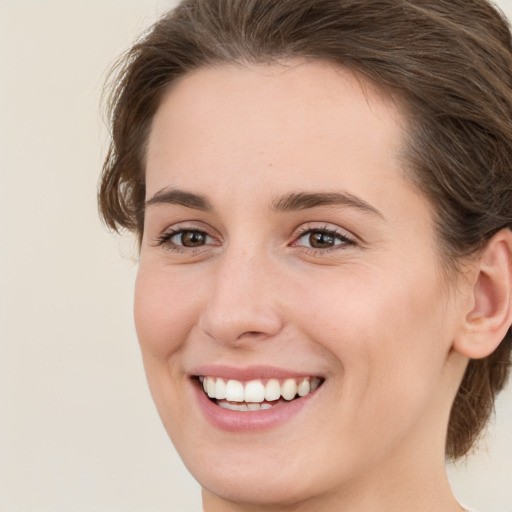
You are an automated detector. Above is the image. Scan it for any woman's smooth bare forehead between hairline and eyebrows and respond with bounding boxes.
[147,61,416,212]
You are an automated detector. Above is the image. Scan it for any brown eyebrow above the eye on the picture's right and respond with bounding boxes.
[272,192,384,219]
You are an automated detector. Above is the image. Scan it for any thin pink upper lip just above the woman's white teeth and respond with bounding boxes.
[190,365,322,381]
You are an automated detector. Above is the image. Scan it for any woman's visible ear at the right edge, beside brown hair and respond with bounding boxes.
[453,229,512,359]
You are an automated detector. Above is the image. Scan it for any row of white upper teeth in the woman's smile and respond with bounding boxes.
[199,377,321,403]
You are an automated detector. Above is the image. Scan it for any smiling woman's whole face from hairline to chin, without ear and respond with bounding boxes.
[135,62,468,510]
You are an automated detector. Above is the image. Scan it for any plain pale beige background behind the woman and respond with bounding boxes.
[0,0,512,512]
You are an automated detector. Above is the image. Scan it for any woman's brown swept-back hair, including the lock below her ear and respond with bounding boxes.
[99,0,512,458]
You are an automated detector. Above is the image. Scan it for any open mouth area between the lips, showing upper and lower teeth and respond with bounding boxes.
[198,375,325,412]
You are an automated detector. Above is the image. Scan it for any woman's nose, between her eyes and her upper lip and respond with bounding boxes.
[199,248,283,347]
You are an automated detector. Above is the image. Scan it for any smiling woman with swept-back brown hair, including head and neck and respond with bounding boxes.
[99,0,512,512]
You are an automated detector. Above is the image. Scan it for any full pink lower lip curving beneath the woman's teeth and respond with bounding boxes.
[192,380,316,432]
